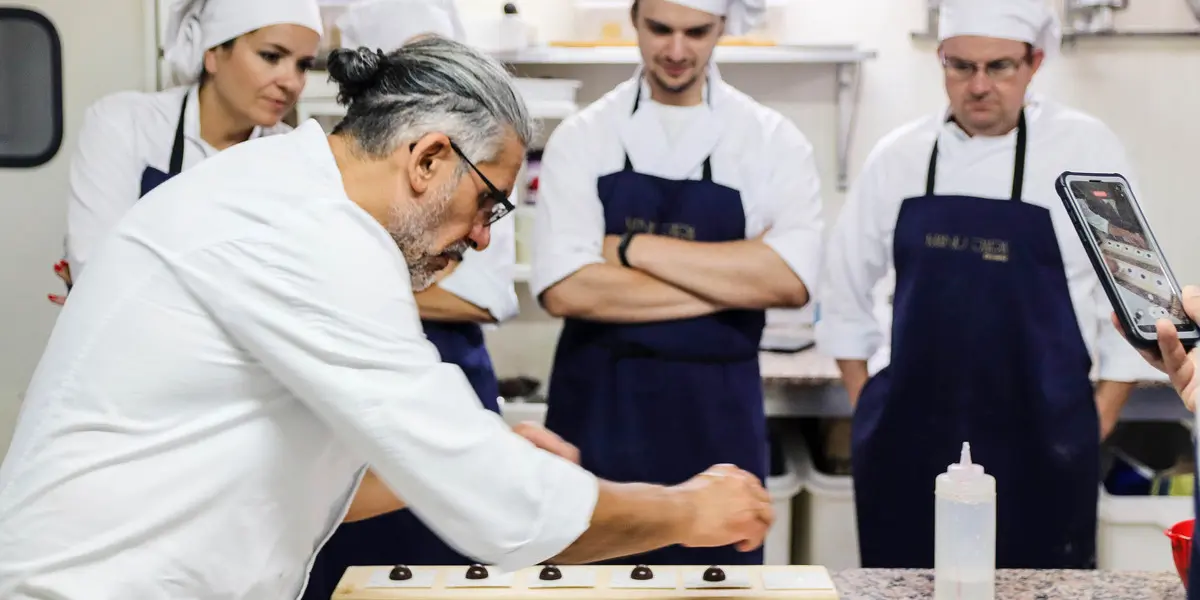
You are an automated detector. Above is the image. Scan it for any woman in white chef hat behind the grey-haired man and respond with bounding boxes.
[50,0,322,304]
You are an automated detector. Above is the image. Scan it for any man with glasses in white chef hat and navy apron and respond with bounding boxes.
[816,0,1154,569]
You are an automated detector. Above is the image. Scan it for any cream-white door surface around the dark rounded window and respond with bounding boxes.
[0,0,157,455]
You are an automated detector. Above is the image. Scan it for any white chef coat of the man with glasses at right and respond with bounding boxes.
[815,96,1162,382]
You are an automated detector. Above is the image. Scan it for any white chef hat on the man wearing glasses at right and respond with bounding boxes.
[938,0,1062,56]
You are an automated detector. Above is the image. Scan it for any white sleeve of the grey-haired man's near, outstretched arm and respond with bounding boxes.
[176,214,599,570]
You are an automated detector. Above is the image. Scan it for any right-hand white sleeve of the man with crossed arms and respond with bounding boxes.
[763,121,824,299]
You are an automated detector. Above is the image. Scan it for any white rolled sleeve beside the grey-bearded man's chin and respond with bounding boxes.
[438,193,521,323]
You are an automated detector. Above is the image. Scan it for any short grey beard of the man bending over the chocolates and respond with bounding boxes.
[388,181,469,292]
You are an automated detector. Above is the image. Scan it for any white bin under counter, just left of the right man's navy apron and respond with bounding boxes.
[787,434,864,571]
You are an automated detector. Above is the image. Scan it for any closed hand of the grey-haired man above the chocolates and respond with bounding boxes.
[676,464,775,552]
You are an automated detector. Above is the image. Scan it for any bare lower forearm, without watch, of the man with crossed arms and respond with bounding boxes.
[541,263,716,323]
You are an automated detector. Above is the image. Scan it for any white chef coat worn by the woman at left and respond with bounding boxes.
[66,85,292,281]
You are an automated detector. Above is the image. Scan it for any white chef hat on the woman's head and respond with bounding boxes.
[163,0,324,85]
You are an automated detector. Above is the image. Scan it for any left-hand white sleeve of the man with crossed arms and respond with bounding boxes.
[530,127,605,298]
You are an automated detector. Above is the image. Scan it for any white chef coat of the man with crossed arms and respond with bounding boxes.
[530,68,824,295]
